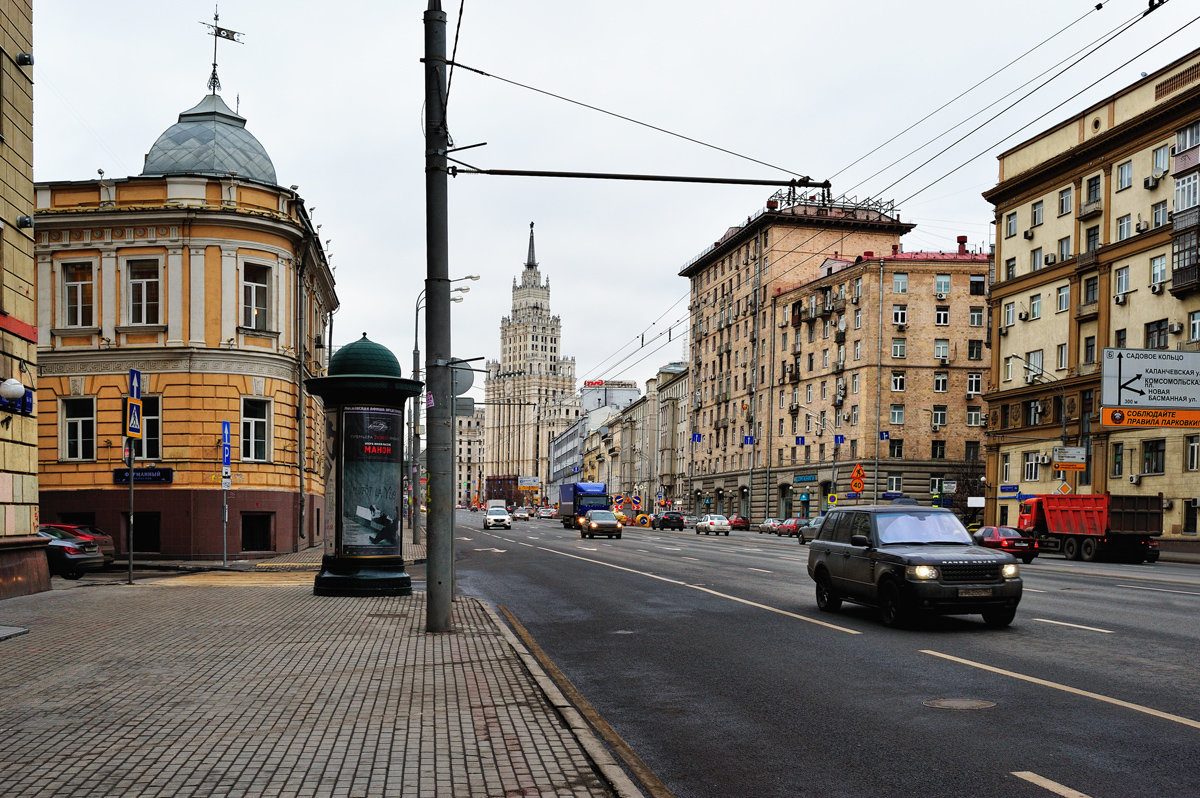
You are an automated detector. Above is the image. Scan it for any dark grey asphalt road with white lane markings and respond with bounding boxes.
[446,512,1200,798]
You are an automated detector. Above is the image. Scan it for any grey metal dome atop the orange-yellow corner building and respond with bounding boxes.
[142,94,276,186]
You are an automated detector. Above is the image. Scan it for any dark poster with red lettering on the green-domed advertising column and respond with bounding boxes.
[342,407,404,557]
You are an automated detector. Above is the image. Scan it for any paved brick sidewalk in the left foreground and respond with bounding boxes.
[0,571,641,798]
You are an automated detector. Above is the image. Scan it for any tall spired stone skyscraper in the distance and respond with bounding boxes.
[484,222,580,504]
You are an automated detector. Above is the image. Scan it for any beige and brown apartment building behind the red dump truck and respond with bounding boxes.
[985,45,1200,540]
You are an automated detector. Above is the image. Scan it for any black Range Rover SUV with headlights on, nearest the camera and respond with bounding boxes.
[809,505,1021,626]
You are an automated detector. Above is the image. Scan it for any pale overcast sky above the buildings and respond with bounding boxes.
[34,0,1200,398]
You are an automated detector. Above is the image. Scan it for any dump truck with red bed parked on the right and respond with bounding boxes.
[1016,493,1163,563]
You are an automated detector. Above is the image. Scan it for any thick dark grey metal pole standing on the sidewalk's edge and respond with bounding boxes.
[425,0,454,632]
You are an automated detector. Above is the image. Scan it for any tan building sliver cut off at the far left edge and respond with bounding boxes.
[0,0,40,599]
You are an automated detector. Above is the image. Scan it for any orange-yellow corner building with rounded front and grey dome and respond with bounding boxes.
[36,94,337,559]
